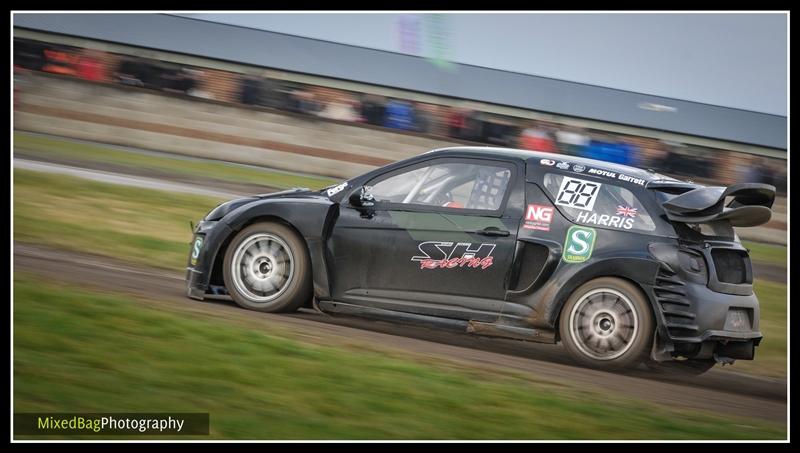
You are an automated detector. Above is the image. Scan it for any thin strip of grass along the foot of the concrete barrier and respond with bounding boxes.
[14,132,339,189]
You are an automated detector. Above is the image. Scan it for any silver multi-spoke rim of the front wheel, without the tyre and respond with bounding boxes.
[231,233,294,303]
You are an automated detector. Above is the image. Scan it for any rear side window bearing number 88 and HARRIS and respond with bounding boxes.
[544,173,656,231]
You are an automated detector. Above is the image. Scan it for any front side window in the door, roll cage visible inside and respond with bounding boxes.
[370,162,511,211]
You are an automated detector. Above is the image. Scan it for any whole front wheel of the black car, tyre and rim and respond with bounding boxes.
[222,222,312,313]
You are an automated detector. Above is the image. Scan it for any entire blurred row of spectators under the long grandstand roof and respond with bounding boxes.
[14,40,786,191]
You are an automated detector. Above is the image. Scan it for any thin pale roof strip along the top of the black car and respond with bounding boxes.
[425,146,677,185]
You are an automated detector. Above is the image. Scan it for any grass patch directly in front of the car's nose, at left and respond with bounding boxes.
[14,170,222,269]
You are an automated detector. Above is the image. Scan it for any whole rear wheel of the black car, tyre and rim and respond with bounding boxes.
[558,277,655,368]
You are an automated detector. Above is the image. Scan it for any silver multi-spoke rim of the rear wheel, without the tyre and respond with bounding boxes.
[569,288,639,360]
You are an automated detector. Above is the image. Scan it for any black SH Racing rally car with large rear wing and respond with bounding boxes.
[186,147,775,372]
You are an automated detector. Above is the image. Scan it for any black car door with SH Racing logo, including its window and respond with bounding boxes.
[328,158,524,321]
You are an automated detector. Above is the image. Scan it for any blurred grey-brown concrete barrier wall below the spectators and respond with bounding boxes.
[14,74,466,177]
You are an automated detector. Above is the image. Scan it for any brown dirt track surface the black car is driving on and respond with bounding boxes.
[14,243,787,422]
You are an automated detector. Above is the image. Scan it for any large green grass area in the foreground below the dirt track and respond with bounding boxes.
[14,275,786,439]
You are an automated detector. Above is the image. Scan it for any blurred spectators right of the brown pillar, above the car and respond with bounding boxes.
[230,74,786,192]
